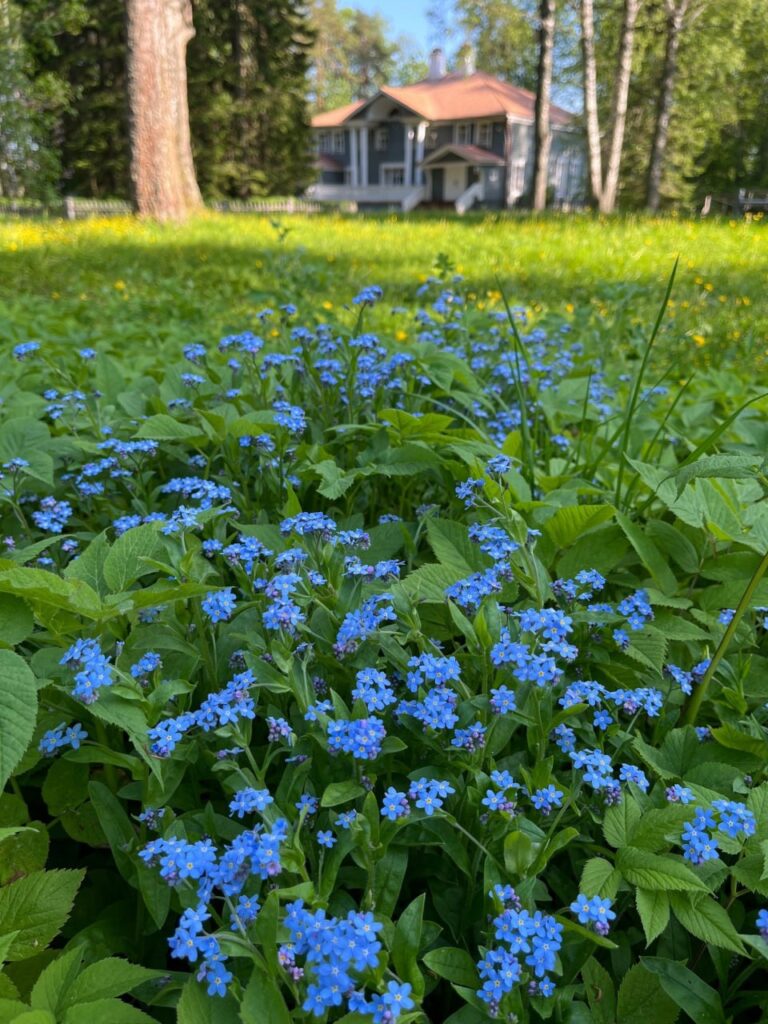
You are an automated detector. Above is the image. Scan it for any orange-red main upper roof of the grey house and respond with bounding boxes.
[312,71,573,128]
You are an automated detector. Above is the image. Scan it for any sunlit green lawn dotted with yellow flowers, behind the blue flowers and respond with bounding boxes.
[0,214,768,373]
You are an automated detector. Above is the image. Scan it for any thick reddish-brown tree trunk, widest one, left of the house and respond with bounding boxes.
[126,0,202,220]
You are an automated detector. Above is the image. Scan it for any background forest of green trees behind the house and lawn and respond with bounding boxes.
[0,0,768,208]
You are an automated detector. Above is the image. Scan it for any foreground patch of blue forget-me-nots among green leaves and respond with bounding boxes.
[0,234,768,1024]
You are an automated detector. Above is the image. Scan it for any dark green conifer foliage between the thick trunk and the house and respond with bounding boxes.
[187,0,312,198]
